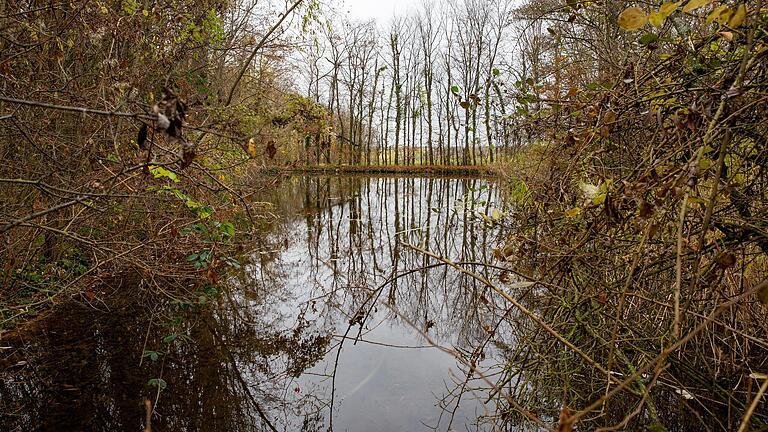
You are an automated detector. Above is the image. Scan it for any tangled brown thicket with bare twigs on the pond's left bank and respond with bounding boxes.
[0,0,318,326]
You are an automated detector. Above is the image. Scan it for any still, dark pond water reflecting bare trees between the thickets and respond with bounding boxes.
[0,176,516,431]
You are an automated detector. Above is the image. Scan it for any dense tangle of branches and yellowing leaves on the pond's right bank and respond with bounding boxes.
[492,0,768,430]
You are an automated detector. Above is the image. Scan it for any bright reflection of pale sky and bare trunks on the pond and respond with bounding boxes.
[237,177,510,431]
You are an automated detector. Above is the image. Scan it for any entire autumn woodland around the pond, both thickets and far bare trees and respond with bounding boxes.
[0,0,768,431]
